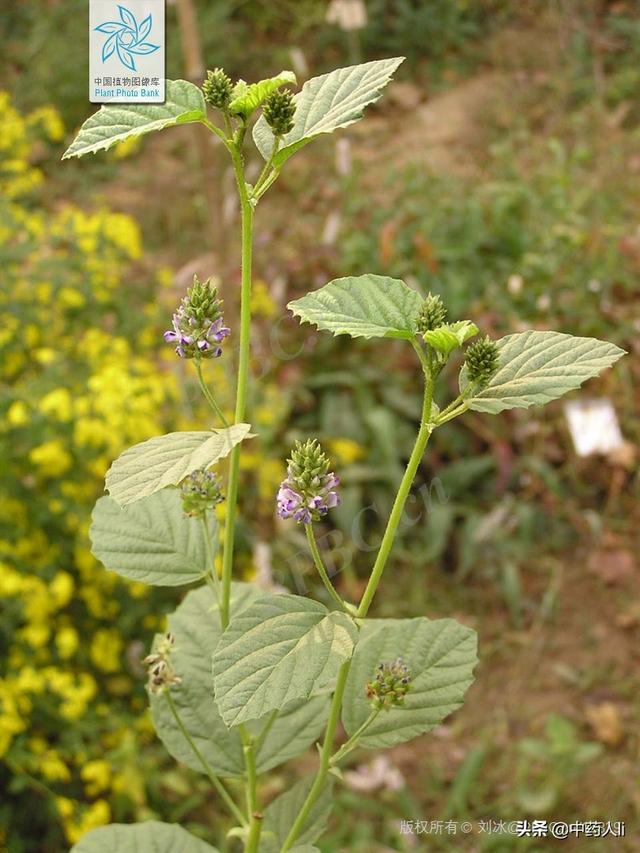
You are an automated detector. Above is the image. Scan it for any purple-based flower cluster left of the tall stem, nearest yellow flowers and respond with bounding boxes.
[164,276,230,358]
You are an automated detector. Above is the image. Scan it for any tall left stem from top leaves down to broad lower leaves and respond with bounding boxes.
[220,147,253,629]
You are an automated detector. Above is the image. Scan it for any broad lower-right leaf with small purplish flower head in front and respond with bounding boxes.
[342,617,477,749]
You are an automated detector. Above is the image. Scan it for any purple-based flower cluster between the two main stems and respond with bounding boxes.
[277,439,340,524]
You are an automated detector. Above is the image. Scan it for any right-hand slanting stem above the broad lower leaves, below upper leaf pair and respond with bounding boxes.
[357,375,434,619]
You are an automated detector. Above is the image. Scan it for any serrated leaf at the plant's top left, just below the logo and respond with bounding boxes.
[62,80,206,160]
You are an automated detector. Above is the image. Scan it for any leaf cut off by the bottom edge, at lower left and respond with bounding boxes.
[71,820,219,853]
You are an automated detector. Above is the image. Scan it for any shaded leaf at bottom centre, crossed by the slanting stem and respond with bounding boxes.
[260,775,333,853]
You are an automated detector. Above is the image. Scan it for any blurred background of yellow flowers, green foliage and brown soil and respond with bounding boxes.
[0,0,640,853]
